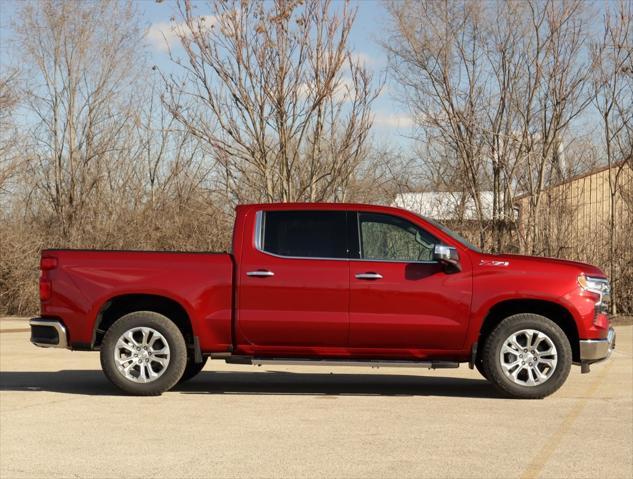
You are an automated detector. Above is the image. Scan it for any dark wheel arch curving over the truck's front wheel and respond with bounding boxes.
[477,299,580,361]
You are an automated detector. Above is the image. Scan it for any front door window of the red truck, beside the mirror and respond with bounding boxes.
[358,213,438,262]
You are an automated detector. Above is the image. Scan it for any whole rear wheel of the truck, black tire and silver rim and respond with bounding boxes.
[101,311,187,396]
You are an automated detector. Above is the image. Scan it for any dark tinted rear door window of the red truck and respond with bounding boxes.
[263,211,347,258]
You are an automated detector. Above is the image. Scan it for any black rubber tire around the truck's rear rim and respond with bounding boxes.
[100,311,187,396]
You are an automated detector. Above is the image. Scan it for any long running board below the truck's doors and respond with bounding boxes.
[223,356,459,369]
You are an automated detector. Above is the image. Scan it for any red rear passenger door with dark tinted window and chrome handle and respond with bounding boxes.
[236,210,349,353]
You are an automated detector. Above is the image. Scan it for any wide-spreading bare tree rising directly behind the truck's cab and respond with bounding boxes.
[167,0,377,202]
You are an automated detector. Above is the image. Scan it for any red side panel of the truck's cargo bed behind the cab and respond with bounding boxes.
[42,249,233,351]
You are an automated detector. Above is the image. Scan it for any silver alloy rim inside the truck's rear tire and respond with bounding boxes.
[114,327,169,383]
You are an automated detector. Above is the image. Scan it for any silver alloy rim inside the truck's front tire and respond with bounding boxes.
[499,329,558,386]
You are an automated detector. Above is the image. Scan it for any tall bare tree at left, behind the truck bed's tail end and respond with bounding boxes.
[15,0,143,239]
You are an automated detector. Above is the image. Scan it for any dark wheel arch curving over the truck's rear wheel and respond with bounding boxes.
[91,294,194,349]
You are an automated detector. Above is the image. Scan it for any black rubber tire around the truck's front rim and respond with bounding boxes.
[482,314,572,399]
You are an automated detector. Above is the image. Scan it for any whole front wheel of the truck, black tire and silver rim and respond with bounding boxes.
[482,314,572,399]
